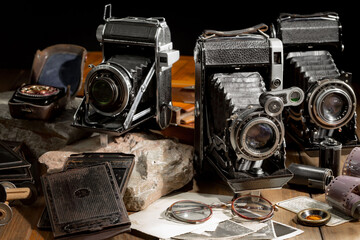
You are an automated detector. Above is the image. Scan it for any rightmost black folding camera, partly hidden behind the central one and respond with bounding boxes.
[273,12,359,154]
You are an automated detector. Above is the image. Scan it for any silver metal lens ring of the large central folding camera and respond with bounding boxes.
[230,112,284,161]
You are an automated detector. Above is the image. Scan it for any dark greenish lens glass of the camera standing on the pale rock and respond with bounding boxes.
[90,80,115,105]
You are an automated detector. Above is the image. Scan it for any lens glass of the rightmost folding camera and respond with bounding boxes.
[320,93,348,122]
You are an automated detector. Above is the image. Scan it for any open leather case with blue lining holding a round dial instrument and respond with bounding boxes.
[8,44,86,121]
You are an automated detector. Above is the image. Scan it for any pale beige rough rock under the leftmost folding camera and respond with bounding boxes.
[39,132,194,211]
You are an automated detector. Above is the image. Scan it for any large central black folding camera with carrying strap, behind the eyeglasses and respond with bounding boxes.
[194,25,304,192]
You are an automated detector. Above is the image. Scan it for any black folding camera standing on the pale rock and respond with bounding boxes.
[73,5,179,133]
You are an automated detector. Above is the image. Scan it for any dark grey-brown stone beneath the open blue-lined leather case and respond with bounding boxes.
[0,91,90,157]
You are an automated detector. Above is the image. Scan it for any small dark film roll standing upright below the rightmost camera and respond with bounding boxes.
[319,138,342,177]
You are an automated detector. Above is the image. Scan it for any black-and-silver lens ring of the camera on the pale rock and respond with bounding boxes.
[85,63,131,116]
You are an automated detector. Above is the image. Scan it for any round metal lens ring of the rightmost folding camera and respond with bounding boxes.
[308,79,356,129]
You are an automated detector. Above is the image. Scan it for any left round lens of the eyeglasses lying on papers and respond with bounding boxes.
[167,200,212,223]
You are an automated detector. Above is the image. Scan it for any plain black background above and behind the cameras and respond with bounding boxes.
[0,0,359,76]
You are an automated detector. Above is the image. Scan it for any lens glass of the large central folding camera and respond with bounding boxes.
[245,123,274,151]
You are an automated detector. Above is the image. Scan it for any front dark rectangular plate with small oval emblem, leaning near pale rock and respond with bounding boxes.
[41,162,130,238]
